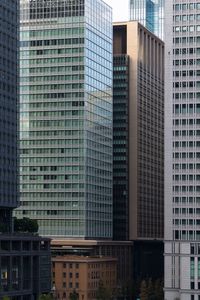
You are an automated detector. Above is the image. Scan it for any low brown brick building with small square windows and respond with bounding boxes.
[52,255,117,300]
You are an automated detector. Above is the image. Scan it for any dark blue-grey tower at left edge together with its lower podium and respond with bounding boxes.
[0,0,51,300]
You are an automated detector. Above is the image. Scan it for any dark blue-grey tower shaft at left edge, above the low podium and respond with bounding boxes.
[0,0,18,232]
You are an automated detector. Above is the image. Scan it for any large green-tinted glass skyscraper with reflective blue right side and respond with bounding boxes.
[16,0,112,239]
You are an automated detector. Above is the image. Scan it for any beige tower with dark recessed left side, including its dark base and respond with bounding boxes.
[113,21,164,277]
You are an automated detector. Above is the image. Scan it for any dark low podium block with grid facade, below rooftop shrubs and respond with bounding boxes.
[0,233,51,300]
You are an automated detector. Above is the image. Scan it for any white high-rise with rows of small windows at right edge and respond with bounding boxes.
[165,0,200,300]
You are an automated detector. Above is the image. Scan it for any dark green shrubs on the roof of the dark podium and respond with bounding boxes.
[14,218,38,233]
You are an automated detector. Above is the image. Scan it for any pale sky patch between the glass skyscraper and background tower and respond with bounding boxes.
[104,0,129,22]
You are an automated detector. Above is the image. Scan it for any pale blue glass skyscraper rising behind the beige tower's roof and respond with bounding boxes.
[130,0,164,39]
